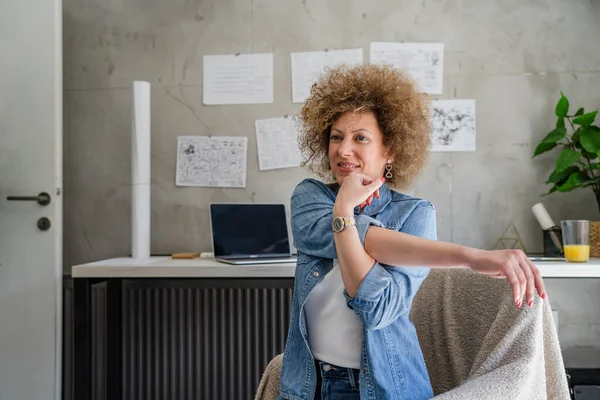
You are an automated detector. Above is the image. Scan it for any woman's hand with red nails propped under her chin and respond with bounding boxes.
[333,172,385,215]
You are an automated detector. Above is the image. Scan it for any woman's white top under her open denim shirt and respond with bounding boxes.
[304,259,363,369]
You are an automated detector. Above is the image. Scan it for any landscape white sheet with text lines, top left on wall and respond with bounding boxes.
[203,53,273,105]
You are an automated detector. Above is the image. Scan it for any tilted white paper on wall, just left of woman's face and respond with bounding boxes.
[254,117,303,171]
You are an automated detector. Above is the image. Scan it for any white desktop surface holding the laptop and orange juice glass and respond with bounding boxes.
[71,256,600,278]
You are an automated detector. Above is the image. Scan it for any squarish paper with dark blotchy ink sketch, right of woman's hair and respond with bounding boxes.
[431,100,476,151]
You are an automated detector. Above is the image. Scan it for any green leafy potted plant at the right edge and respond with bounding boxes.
[533,92,600,257]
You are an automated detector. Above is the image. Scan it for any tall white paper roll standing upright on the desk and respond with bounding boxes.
[131,81,150,258]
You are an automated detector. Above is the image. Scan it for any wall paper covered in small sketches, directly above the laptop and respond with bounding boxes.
[176,136,248,188]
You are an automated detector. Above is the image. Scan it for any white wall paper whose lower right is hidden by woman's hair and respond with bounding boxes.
[291,48,363,103]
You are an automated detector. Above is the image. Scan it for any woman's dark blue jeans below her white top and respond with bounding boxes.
[315,361,360,400]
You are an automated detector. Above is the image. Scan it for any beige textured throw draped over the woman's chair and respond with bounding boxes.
[255,269,570,400]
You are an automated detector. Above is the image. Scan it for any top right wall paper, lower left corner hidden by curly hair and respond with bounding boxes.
[371,42,444,94]
